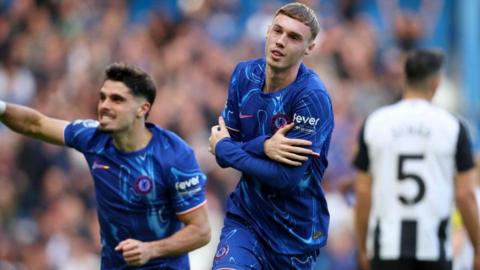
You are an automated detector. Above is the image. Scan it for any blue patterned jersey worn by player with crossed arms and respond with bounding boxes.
[215,59,333,254]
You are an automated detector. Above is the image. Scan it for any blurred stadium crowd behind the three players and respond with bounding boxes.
[0,0,480,270]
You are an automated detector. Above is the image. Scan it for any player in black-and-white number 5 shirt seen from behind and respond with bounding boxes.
[354,50,480,270]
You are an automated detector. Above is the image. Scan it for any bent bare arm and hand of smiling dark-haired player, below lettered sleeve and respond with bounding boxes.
[115,205,210,266]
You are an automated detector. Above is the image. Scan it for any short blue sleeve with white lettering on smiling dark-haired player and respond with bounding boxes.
[169,148,207,215]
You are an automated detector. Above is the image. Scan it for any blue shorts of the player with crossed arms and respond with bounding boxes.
[212,215,319,270]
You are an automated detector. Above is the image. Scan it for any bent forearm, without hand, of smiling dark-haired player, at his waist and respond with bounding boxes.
[150,218,210,258]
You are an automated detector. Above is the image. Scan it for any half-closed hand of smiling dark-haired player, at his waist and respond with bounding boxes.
[115,239,152,266]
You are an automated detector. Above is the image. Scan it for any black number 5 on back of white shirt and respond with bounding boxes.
[397,155,425,205]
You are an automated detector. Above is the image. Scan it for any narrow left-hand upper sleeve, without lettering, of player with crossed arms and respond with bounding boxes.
[222,64,242,141]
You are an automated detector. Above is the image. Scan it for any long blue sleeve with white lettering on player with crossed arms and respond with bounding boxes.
[215,91,333,189]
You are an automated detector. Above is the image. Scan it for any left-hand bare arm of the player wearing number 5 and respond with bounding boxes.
[355,171,372,270]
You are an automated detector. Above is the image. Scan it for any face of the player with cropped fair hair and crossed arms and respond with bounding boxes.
[265,14,315,69]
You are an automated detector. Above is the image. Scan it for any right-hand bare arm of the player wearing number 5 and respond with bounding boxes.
[455,168,480,270]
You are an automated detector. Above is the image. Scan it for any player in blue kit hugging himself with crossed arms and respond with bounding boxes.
[210,3,333,270]
